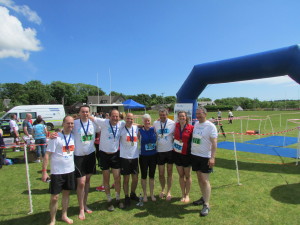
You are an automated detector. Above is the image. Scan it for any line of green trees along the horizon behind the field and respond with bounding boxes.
[0,80,300,110]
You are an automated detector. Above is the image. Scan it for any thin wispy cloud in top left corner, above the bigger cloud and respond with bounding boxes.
[0,0,42,24]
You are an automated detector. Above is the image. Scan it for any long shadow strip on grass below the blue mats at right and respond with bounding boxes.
[215,158,299,174]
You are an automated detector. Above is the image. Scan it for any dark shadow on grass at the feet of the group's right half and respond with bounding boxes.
[134,198,200,219]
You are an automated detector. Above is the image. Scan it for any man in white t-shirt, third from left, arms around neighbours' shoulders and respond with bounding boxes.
[93,109,125,211]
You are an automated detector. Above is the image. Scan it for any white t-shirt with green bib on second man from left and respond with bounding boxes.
[72,119,96,156]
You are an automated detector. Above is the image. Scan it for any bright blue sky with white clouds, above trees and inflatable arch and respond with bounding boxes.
[0,0,300,100]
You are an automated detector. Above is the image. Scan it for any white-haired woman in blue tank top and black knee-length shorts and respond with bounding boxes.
[138,114,157,202]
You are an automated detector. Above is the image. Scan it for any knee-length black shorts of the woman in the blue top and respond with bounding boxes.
[139,154,157,179]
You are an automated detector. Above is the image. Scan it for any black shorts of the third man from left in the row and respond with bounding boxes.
[99,150,121,170]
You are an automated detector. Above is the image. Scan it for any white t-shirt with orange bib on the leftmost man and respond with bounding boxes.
[46,133,75,174]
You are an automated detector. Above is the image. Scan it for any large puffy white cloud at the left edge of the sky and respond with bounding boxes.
[0,6,41,60]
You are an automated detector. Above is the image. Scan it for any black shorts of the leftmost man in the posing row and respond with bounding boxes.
[49,171,76,195]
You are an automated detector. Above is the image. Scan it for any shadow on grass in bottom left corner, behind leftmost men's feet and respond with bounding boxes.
[0,202,107,225]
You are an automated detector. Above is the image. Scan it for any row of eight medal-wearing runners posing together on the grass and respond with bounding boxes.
[42,105,218,224]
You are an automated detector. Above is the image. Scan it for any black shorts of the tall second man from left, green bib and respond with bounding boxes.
[74,152,96,178]
